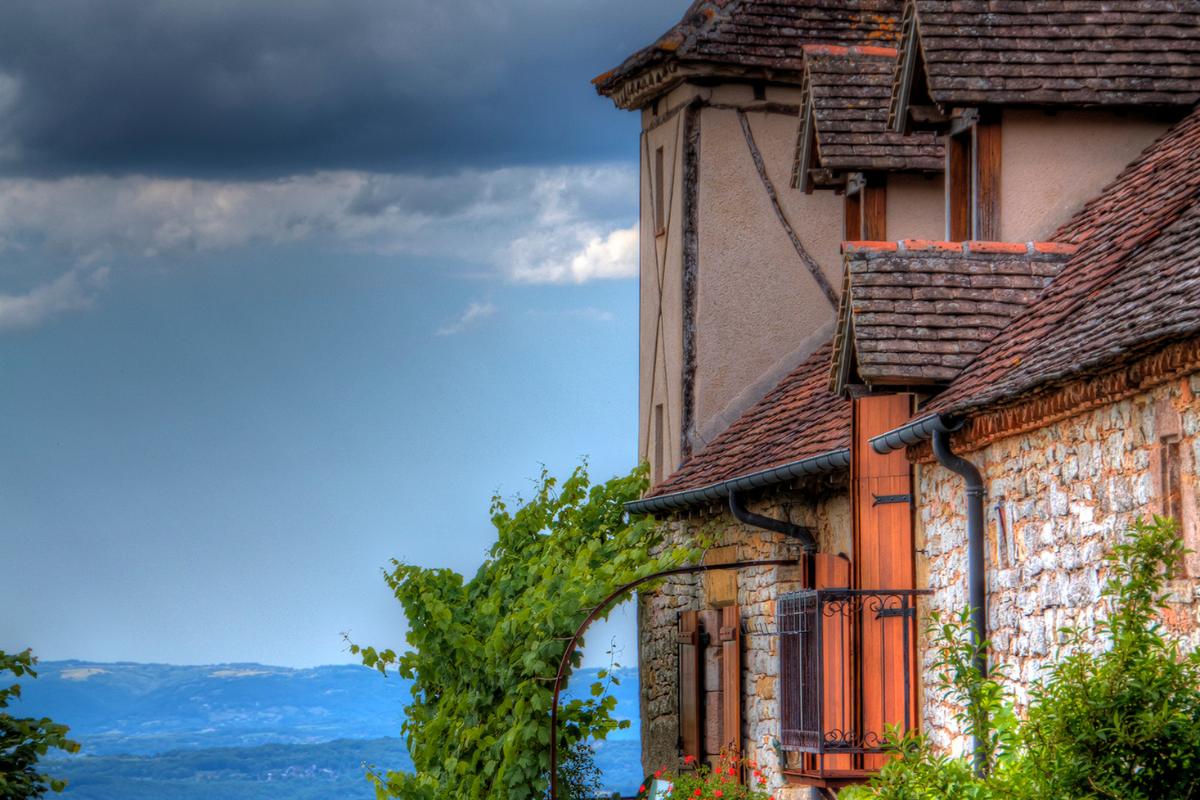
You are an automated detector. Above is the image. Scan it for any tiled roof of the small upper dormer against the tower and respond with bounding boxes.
[798,44,944,172]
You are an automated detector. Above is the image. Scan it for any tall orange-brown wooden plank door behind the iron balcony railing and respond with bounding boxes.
[851,395,916,769]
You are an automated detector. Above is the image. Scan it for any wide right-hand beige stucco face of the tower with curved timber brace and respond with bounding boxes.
[696,85,841,450]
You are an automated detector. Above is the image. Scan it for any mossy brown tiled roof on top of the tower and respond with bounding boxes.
[593,0,902,107]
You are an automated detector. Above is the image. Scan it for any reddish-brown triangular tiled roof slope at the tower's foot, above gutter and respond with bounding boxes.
[648,343,850,497]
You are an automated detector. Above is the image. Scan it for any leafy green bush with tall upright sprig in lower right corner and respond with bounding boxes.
[1025,517,1200,800]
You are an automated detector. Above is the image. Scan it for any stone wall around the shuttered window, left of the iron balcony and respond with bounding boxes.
[637,479,851,800]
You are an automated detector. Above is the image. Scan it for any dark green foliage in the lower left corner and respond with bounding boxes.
[0,650,79,800]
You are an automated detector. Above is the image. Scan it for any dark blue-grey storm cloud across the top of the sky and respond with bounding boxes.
[0,0,686,178]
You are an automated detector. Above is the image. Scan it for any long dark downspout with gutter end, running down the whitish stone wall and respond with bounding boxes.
[871,414,988,774]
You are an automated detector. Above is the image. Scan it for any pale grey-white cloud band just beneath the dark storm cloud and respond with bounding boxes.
[0,164,637,283]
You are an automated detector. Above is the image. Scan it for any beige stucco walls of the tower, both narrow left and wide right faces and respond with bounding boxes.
[638,84,841,477]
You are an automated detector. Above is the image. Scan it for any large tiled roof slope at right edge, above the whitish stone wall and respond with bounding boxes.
[928,104,1200,414]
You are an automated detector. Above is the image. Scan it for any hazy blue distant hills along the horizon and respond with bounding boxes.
[18,661,642,800]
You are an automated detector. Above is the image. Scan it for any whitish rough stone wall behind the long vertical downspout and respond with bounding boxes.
[917,375,1200,750]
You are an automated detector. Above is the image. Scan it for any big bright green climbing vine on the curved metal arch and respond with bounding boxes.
[352,465,685,800]
